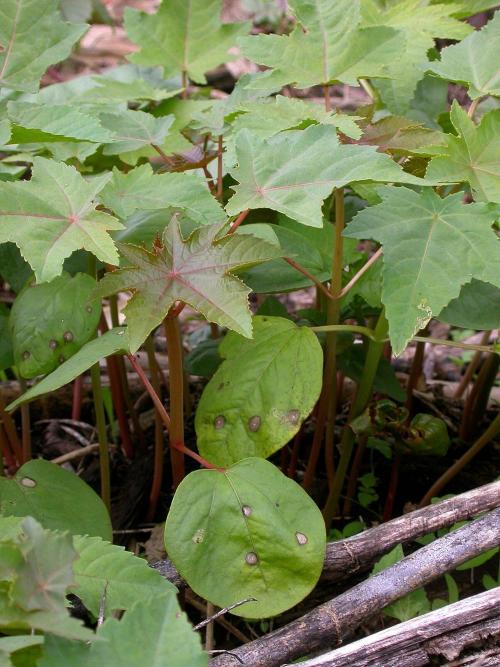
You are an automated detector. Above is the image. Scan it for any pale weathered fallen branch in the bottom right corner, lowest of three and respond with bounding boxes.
[283,588,500,667]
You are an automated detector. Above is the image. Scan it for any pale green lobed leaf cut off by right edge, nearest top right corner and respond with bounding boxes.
[426,12,500,100]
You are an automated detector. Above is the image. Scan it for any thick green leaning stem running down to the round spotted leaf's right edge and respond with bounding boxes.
[323,310,389,527]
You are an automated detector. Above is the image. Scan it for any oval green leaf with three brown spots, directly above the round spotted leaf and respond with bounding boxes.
[195,316,323,466]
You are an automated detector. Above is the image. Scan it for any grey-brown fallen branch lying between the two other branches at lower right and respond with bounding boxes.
[210,508,500,667]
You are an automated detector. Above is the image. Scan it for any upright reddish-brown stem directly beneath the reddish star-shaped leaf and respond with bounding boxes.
[165,315,185,489]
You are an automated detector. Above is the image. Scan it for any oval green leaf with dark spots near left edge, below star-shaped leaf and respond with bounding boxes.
[10,273,101,378]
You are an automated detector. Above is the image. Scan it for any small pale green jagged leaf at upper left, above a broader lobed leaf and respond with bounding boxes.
[100,109,174,155]
